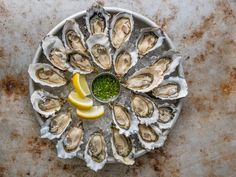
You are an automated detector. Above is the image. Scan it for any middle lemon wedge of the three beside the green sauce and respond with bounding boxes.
[68,91,93,109]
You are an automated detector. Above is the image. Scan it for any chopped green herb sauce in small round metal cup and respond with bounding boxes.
[92,74,120,101]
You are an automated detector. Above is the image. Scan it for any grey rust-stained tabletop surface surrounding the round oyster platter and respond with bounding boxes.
[0,0,236,177]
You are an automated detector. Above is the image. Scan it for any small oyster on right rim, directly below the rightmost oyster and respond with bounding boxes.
[157,103,178,129]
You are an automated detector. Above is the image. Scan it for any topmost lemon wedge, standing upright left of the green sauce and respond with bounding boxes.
[71,73,91,98]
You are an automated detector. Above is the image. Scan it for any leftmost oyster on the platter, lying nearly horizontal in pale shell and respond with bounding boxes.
[28,63,67,87]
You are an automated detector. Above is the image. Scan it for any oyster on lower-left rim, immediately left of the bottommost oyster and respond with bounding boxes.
[56,121,84,159]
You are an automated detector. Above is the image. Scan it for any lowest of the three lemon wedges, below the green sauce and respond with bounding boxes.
[76,106,104,119]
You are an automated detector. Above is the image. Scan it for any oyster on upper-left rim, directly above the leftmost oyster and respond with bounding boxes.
[42,35,69,71]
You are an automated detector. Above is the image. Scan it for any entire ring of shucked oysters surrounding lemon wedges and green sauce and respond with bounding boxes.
[28,5,188,171]
